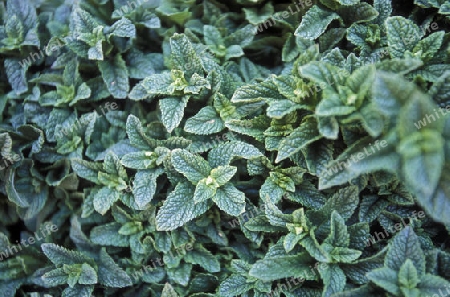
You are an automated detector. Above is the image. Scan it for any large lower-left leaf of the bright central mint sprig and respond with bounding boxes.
[156,183,210,231]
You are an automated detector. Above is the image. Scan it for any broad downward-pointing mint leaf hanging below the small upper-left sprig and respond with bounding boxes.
[98,54,130,99]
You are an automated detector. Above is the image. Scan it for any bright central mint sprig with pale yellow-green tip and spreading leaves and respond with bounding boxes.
[156,142,261,230]
